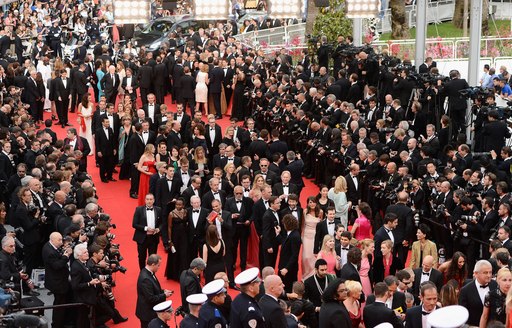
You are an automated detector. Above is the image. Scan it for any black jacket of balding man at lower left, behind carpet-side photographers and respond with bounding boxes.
[42,242,69,294]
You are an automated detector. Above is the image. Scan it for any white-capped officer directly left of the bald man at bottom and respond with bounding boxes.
[231,268,265,328]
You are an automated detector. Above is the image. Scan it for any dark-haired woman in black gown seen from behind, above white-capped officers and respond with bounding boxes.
[203,224,226,283]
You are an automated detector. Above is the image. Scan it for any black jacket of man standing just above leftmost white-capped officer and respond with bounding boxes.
[135,268,166,321]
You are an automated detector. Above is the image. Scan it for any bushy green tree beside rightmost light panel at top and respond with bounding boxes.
[306,0,352,42]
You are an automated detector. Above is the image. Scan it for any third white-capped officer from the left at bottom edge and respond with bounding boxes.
[199,279,228,328]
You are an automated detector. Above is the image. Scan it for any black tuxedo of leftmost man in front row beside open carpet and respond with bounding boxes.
[132,206,162,269]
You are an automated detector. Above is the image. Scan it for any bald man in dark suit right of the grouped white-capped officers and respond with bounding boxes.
[258,275,288,328]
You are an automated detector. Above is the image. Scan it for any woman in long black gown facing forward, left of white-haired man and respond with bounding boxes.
[165,198,190,281]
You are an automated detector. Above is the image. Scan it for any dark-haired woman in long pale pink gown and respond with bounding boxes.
[302,196,323,280]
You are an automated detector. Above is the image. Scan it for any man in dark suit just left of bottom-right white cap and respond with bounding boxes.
[405,283,437,328]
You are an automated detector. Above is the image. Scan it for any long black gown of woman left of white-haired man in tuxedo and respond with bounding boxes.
[165,211,190,281]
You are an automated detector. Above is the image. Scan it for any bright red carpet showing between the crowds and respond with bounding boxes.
[45,91,318,328]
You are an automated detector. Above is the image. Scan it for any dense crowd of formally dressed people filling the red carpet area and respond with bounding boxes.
[0,2,512,328]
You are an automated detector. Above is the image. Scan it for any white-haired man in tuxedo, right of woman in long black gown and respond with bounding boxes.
[187,196,211,261]
